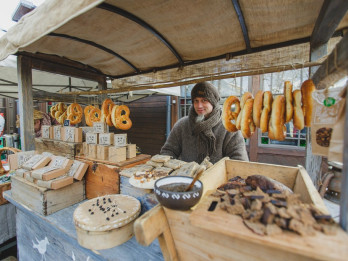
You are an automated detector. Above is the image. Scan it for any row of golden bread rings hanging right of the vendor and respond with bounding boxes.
[222,80,315,141]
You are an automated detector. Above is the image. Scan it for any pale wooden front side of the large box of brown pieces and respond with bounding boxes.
[165,208,313,261]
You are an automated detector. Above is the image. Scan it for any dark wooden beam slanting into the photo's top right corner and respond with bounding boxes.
[311,0,348,49]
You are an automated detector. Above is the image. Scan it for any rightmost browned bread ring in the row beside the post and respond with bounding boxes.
[301,80,315,127]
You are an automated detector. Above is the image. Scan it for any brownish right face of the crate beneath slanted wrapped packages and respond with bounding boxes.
[45,180,86,215]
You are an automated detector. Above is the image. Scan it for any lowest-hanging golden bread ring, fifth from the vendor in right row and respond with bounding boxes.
[268,95,286,141]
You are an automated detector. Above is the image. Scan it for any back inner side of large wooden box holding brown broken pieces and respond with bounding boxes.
[226,160,298,189]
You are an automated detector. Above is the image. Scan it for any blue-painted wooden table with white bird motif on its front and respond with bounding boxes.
[4,191,163,261]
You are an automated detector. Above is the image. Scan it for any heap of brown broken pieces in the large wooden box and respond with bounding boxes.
[210,175,337,235]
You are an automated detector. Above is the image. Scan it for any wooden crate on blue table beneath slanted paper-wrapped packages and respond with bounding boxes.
[11,176,86,216]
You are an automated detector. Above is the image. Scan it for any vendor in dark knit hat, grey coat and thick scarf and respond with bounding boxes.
[160,82,249,163]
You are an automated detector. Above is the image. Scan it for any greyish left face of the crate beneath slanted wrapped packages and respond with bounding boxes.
[11,177,47,215]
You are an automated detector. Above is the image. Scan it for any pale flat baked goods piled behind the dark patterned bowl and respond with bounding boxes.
[120,154,213,189]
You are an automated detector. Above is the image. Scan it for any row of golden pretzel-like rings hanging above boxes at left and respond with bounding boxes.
[50,98,132,130]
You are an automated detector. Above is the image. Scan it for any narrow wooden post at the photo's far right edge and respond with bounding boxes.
[340,90,348,232]
